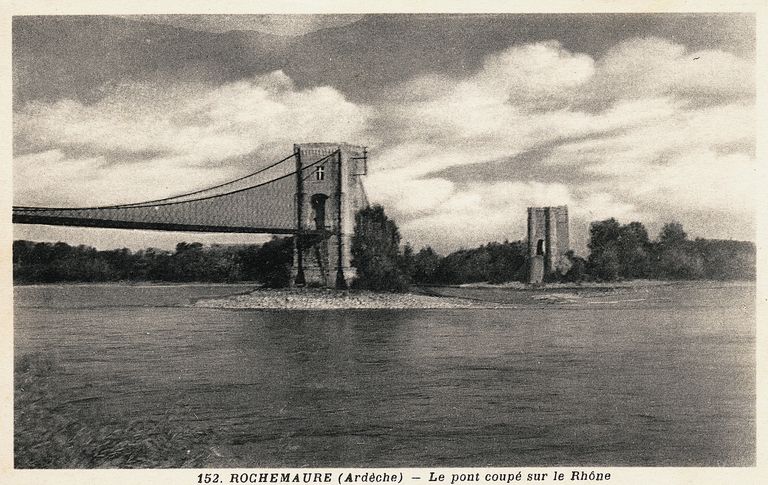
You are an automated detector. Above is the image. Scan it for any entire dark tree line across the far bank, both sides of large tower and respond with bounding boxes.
[13,205,755,291]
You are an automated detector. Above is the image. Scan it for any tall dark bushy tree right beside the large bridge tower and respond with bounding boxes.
[351,205,408,291]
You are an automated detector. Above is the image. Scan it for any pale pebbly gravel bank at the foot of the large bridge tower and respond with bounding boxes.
[194,288,508,310]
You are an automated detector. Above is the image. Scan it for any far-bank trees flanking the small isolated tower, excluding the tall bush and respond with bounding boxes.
[405,219,755,284]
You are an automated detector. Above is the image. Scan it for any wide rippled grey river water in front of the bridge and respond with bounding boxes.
[15,284,755,467]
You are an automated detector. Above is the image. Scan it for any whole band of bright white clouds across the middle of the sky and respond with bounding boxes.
[14,38,757,251]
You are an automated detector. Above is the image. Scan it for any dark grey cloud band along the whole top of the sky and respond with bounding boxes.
[13,14,755,106]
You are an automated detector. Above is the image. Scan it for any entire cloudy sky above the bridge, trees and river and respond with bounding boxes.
[13,14,758,254]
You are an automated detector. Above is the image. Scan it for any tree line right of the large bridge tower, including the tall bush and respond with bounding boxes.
[352,206,756,291]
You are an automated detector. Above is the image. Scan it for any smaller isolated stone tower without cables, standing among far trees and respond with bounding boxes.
[528,206,569,283]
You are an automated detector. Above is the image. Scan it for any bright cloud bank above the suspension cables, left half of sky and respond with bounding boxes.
[14,71,370,205]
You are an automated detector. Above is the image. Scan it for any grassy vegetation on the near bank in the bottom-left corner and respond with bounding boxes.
[13,353,209,468]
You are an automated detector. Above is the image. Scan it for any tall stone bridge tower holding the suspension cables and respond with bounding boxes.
[293,143,368,288]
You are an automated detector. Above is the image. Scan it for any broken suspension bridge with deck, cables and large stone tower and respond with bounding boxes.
[13,143,368,287]
